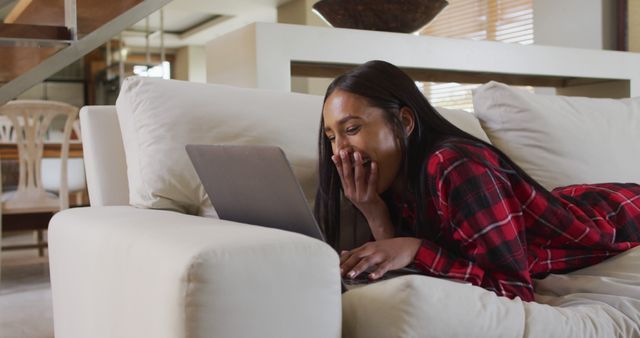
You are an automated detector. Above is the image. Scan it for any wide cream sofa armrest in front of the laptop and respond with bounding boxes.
[49,206,342,338]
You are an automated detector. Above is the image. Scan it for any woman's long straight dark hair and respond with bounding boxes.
[314,60,551,250]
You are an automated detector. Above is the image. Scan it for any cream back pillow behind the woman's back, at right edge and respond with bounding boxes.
[473,81,640,189]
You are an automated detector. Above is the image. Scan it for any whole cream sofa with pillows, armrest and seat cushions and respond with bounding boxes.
[49,78,640,338]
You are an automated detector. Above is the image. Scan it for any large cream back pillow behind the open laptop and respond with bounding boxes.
[116,77,322,216]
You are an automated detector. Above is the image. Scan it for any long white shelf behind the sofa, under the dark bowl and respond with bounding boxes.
[206,23,640,97]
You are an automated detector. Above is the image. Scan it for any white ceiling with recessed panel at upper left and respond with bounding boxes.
[121,0,291,48]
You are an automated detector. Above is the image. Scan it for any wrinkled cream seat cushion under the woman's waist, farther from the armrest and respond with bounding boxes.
[525,247,640,337]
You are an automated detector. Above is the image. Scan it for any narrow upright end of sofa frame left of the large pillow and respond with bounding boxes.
[80,106,129,206]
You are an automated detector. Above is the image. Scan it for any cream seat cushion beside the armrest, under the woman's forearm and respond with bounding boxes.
[342,275,525,338]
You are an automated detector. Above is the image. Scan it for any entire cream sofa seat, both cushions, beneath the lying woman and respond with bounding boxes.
[342,247,640,338]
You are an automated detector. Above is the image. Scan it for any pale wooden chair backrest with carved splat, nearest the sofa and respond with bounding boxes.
[0,100,78,210]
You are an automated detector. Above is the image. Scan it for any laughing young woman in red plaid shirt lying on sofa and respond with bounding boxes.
[315,61,640,301]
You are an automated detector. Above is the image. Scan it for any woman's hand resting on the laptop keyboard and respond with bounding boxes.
[340,237,422,279]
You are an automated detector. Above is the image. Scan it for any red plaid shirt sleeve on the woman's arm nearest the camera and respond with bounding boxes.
[415,148,533,301]
